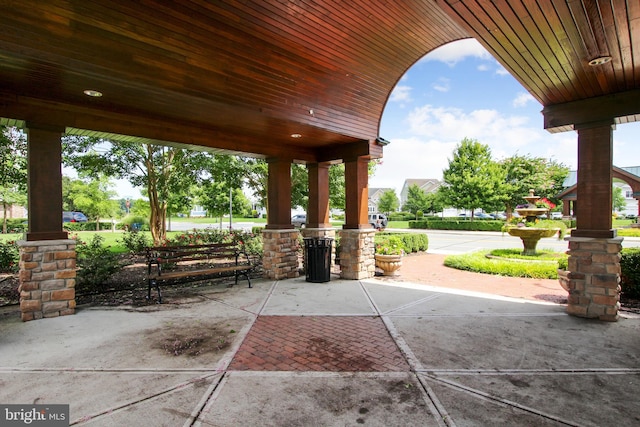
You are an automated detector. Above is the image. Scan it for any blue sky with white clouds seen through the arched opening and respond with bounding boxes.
[369,39,640,195]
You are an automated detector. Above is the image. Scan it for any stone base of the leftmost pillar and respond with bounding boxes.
[18,239,76,322]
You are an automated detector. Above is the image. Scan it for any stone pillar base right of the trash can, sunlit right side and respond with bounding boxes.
[340,229,376,280]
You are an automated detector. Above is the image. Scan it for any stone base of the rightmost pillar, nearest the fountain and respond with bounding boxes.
[565,237,623,322]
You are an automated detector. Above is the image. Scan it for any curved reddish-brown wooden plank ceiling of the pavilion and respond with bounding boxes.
[0,0,640,162]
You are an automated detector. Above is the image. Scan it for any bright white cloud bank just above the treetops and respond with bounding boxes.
[370,105,577,193]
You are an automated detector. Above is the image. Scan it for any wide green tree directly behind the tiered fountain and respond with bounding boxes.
[500,155,569,218]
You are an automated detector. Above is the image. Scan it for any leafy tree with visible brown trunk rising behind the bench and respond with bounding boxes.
[62,136,211,244]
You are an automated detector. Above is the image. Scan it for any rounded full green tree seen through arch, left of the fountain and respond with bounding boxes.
[442,138,505,220]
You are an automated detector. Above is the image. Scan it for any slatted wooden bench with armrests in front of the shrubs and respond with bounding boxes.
[146,243,254,303]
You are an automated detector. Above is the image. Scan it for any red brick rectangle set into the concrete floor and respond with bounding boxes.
[229,316,409,372]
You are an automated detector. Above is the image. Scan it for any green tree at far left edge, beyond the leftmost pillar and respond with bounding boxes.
[0,126,27,234]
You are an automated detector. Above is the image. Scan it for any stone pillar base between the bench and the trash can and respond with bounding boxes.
[262,229,300,280]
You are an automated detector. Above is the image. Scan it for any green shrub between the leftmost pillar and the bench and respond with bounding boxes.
[76,234,123,291]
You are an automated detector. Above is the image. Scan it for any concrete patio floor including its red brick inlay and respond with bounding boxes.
[0,277,640,427]
